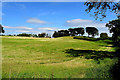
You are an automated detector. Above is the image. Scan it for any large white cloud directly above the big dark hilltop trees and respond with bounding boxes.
[65,19,106,27]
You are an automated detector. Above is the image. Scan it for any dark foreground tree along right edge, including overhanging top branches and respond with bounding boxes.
[85,0,120,80]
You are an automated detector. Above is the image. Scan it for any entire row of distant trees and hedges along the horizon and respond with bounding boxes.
[0,26,108,38]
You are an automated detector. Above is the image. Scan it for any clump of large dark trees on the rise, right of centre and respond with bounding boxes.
[53,27,99,38]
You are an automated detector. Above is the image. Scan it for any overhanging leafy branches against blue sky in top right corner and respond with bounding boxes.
[84,0,119,20]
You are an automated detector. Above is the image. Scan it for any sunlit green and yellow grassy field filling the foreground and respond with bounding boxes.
[2,37,117,78]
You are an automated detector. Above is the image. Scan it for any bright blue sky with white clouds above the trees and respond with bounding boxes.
[2,2,117,36]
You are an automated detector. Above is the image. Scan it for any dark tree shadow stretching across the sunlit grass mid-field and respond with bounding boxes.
[65,49,116,61]
